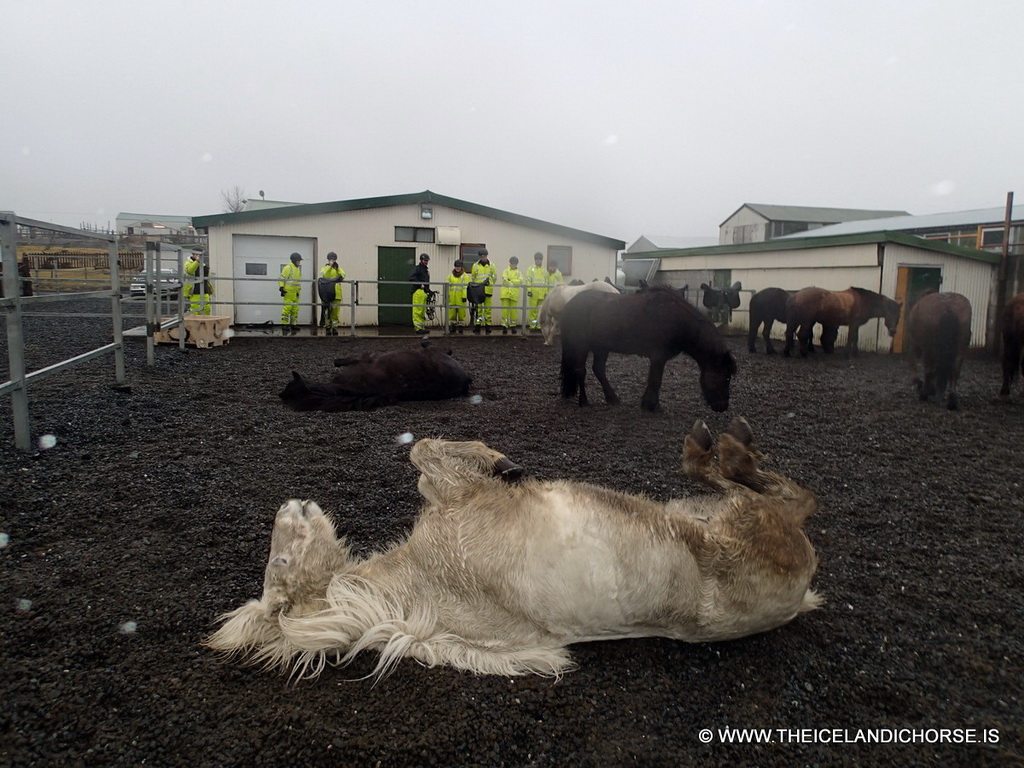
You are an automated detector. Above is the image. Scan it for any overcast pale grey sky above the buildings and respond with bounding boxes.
[0,0,1024,243]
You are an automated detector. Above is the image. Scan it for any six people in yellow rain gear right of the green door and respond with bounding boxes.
[409,249,564,334]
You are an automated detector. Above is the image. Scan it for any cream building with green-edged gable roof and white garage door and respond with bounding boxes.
[193,189,626,326]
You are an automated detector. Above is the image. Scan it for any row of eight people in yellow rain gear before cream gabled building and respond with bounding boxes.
[276,249,564,336]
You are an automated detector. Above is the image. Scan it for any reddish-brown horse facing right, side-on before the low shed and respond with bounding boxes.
[782,288,903,357]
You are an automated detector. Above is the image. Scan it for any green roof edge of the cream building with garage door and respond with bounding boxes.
[193,189,626,251]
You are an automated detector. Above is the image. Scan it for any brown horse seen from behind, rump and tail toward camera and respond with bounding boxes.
[906,293,971,411]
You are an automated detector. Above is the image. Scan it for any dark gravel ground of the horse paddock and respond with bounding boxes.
[0,303,1024,766]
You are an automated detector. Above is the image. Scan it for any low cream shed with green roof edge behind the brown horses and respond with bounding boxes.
[626,231,999,352]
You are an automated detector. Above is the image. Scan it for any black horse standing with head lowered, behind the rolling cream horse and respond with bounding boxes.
[561,287,736,413]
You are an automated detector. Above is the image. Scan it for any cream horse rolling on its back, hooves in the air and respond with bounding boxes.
[206,419,821,677]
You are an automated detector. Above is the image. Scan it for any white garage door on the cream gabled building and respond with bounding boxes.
[231,234,316,325]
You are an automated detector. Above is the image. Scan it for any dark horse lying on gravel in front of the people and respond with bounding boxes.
[281,346,471,411]
